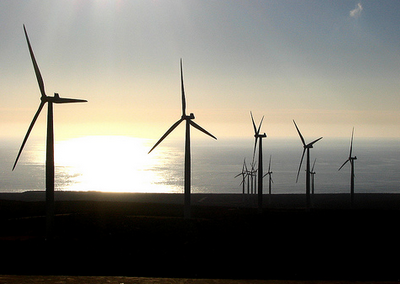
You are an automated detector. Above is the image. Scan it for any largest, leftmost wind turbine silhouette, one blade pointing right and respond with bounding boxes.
[12,25,87,239]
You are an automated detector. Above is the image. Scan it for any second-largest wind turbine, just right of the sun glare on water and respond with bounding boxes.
[149,59,217,219]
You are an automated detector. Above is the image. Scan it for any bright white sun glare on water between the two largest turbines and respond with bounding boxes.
[55,136,170,192]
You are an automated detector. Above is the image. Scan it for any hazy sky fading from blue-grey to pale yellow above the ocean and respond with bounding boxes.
[0,0,400,140]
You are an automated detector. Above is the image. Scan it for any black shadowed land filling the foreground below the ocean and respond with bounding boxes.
[0,193,400,283]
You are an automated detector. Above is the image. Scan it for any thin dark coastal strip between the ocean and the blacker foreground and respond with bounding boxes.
[0,191,400,210]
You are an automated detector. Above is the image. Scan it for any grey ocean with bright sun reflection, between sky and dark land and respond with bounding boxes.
[0,136,400,194]
